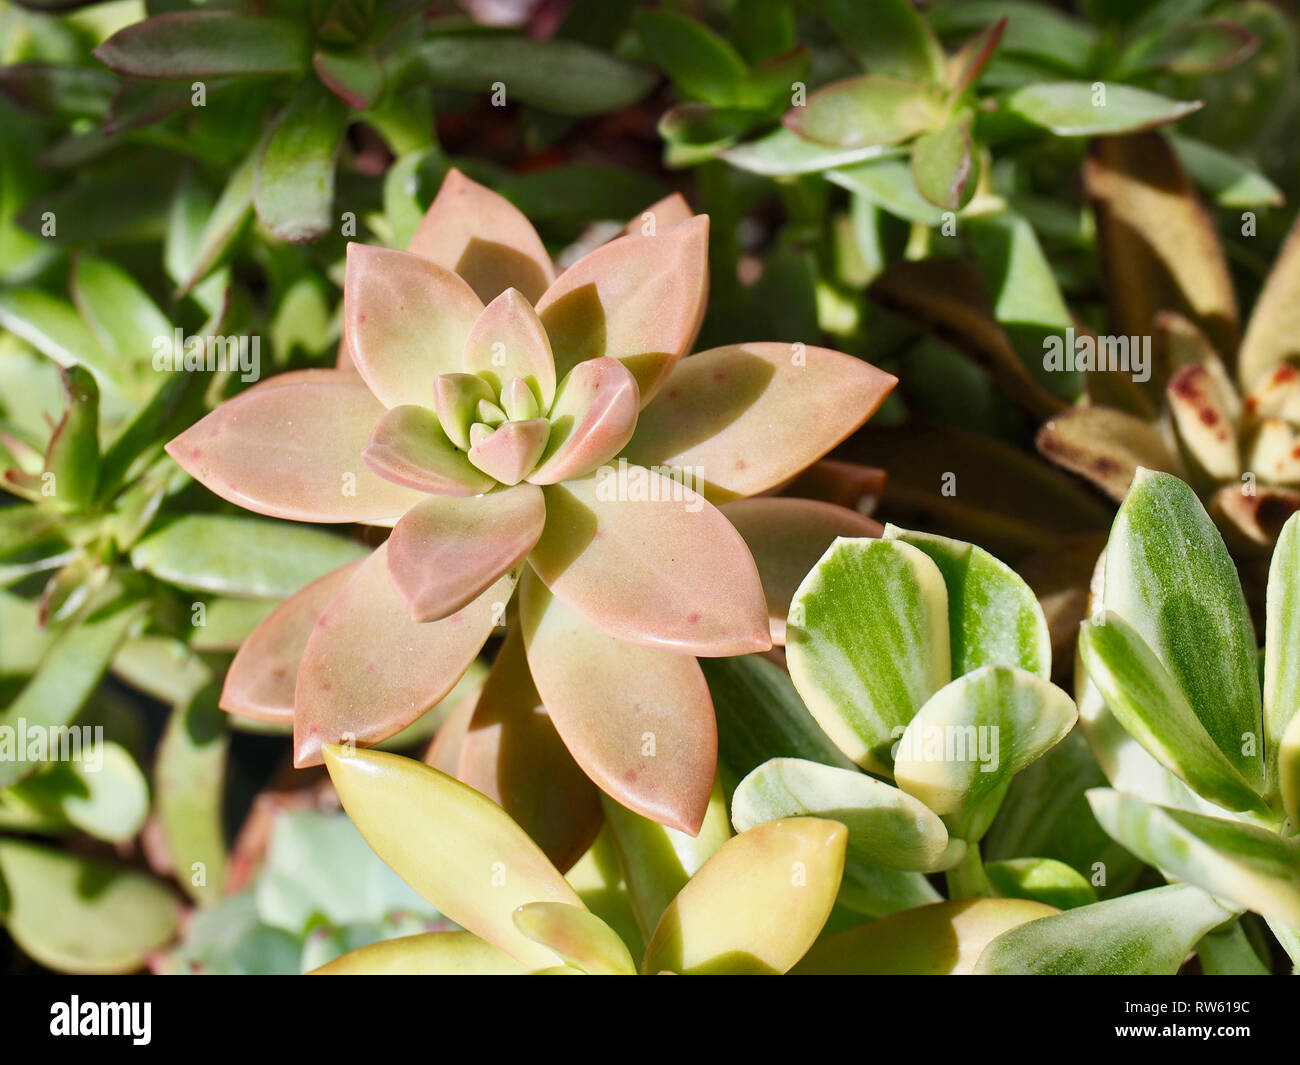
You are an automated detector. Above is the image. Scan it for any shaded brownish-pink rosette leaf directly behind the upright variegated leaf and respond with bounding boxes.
[718,497,884,646]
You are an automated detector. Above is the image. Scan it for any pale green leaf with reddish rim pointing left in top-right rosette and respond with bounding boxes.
[785,74,944,148]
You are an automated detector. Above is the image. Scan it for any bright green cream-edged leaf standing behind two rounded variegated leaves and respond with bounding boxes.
[884,525,1052,680]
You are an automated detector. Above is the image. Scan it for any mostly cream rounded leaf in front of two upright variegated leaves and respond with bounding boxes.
[894,666,1078,839]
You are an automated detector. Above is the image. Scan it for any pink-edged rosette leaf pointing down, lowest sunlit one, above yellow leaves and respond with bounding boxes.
[520,571,718,835]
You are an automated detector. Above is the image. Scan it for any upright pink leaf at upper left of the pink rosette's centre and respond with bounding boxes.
[343,243,484,407]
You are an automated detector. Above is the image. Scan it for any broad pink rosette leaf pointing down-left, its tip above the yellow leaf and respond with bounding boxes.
[294,544,515,767]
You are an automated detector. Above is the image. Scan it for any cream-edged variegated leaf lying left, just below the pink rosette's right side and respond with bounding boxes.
[732,758,948,873]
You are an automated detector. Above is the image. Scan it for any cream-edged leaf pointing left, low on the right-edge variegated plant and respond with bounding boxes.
[1088,788,1300,927]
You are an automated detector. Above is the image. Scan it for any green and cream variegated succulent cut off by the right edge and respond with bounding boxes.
[1078,469,1300,960]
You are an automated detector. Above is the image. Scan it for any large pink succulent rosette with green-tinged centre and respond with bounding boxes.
[168,170,894,842]
